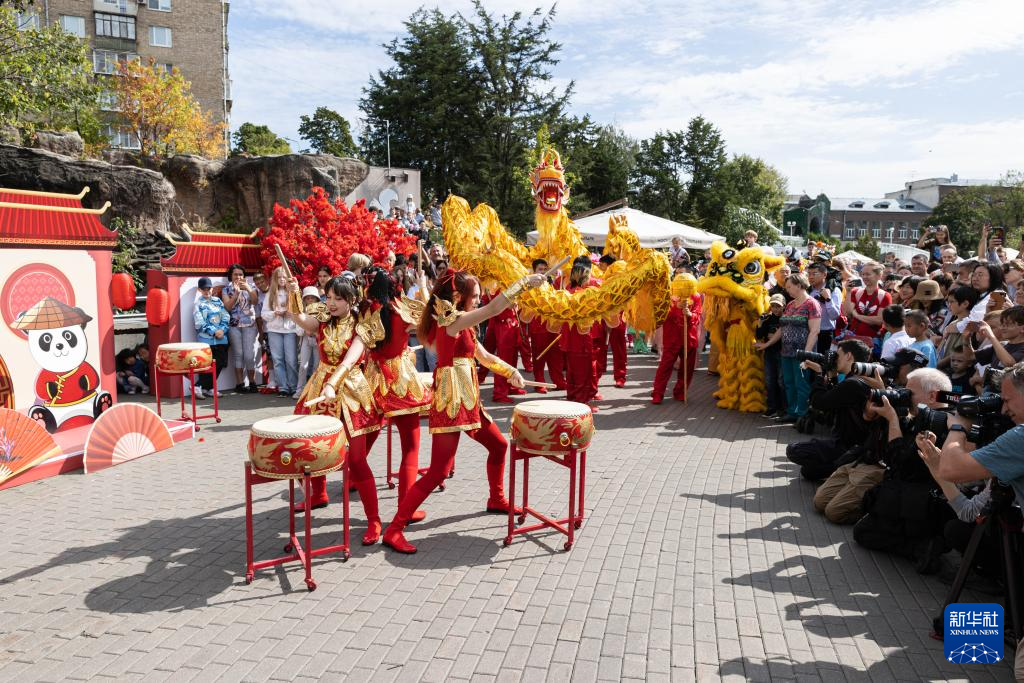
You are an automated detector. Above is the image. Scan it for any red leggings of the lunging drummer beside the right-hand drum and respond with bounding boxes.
[394,418,509,524]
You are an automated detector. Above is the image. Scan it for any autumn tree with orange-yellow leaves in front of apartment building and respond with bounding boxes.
[113,59,226,157]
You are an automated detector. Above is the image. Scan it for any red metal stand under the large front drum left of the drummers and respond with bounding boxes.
[246,460,352,591]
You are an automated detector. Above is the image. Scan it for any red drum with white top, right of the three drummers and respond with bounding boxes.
[511,400,594,455]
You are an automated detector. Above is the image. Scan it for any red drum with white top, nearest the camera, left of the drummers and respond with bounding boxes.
[249,415,348,479]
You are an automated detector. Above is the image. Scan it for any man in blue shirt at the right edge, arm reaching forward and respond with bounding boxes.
[918,362,1024,503]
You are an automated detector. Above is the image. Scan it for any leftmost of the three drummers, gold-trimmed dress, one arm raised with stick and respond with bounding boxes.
[289,278,381,546]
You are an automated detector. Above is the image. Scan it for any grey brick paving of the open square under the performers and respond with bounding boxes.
[0,356,1011,682]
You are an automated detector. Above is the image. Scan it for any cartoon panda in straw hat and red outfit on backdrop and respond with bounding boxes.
[13,297,114,433]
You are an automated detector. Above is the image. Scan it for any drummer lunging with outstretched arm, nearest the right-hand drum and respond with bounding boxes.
[384,270,547,553]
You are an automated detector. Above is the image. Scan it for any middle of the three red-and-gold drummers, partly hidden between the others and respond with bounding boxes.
[360,266,433,521]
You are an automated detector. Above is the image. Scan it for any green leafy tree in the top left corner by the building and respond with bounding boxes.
[0,7,99,136]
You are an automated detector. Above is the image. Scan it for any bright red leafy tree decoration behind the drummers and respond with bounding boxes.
[260,187,416,287]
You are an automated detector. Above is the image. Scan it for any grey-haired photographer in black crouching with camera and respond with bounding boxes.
[853,368,953,573]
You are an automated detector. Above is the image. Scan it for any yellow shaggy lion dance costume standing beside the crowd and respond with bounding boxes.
[697,242,785,413]
